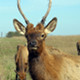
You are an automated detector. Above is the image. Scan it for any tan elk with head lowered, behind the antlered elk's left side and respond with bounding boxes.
[15,45,28,80]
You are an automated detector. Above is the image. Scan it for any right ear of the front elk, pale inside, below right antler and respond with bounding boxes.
[45,18,57,34]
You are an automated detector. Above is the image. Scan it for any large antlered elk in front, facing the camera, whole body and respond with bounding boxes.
[13,0,80,80]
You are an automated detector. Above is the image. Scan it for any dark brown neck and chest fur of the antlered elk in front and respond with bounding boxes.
[29,41,60,80]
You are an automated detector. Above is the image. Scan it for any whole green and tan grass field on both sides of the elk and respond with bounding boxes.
[0,36,80,80]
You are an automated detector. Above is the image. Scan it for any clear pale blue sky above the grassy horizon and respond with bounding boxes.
[0,0,80,36]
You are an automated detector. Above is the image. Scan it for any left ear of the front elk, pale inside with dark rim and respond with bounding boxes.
[13,19,26,35]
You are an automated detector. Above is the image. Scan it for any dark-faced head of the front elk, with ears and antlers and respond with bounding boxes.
[13,0,57,51]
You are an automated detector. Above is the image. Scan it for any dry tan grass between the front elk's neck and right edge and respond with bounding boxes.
[46,36,80,54]
